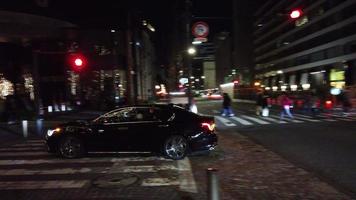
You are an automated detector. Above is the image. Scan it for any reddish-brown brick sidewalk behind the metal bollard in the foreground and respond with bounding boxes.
[191,133,352,200]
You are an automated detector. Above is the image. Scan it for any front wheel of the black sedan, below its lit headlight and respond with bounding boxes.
[59,136,84,158]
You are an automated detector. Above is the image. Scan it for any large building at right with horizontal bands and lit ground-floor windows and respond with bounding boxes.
[253,0,356,100]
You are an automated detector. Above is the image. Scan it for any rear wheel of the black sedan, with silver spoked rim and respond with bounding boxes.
[163,135,188,160]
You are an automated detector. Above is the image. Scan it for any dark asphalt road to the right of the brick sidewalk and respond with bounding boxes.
[198,102,356,196]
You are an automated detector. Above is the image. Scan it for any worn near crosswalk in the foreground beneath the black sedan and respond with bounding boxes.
[0,139,197,198]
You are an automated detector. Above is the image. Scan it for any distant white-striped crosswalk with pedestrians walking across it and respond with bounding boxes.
[213,110,356,127]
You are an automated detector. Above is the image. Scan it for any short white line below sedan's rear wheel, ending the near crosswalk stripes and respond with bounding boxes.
[177,157,198,193]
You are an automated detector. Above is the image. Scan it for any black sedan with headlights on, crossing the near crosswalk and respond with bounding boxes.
[46,105,217,160]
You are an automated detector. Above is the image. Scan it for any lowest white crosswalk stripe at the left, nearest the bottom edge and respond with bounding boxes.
[0,180,90,190]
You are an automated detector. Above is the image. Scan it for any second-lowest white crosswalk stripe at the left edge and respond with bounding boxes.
[0,168,92,176]
